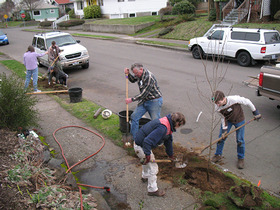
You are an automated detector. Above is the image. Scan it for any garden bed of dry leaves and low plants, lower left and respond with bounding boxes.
[0,129,97,210]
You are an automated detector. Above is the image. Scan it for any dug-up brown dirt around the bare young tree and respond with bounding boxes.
[153,144,278,210]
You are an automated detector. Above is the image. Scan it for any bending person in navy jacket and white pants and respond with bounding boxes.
[134,112,186,196]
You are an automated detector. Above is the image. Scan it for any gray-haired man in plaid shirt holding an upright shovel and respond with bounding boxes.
[124,63,162,139]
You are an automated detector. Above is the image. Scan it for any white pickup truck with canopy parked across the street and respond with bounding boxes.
[188,28,280,66]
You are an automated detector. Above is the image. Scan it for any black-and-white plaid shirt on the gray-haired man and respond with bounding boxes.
[128,69,162,106]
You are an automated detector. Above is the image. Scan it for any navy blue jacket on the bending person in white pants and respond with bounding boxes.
[134,114,176,157]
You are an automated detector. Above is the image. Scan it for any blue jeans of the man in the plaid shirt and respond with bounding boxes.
[130,97,162,139]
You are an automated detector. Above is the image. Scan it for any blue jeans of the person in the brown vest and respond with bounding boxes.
[215,120,245,159]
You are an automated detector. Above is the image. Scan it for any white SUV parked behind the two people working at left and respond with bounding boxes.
[32,32,89,69]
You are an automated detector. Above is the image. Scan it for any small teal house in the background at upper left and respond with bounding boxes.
[25,2,59,22]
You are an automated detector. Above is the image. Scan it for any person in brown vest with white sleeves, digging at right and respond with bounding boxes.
[211,90,261,169]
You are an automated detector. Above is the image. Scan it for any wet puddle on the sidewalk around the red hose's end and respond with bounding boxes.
[77,161,128,210]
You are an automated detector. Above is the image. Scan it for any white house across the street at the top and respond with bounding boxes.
[70,0,168,19]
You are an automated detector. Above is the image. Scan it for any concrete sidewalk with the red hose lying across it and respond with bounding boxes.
[0,62,196,210]
